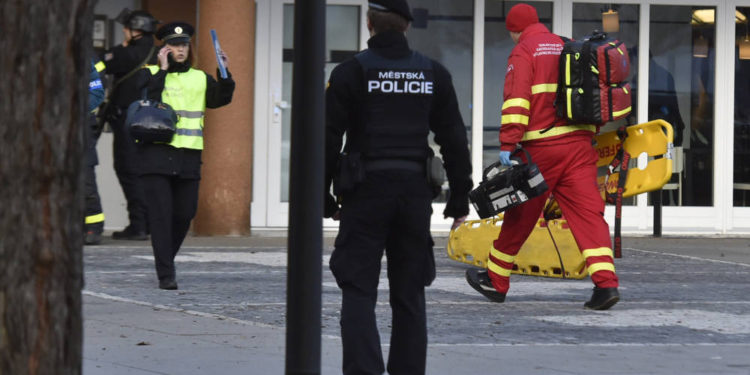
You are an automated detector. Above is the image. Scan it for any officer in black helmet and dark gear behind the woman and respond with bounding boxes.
[100,8,158,240]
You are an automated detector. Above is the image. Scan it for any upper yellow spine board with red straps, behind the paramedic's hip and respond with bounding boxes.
[594,120,674,198]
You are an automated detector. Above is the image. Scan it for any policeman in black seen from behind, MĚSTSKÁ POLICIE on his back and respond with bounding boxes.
[325,0,472,374]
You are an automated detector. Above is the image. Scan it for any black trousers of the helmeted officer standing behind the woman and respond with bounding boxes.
[110,115,147,232]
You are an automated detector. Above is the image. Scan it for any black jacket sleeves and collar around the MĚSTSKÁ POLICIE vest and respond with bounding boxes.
[325,32,472,218]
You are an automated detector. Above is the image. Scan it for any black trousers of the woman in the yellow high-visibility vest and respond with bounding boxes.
[141,174,200,280]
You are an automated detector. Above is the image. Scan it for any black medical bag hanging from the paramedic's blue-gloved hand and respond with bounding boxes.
[469,147,547,219]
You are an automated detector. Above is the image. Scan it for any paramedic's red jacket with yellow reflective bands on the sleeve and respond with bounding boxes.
[500,23,598,151]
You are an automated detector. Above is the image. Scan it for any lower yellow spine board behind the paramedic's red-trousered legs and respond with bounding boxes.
[447,216,588,279]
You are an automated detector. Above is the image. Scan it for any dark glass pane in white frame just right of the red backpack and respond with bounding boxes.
[648,5,716,206]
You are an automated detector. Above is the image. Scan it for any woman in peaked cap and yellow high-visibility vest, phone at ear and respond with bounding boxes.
[138,22,234,289]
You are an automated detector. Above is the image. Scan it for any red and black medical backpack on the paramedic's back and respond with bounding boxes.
[555,31,632,125]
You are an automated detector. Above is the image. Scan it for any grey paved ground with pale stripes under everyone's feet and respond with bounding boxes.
[84,233,750,375]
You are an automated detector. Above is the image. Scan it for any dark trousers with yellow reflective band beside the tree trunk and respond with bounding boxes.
[83,113,104,234]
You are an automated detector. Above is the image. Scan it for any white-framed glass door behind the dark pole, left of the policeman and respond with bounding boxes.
[251,0,367,227]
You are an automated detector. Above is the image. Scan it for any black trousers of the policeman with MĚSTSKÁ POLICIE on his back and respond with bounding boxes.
[330,171,435,375]
